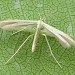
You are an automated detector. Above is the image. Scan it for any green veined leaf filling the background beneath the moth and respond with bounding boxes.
[0,0,75,75]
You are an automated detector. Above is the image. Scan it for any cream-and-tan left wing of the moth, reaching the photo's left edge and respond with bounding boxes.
[0,20,37,30]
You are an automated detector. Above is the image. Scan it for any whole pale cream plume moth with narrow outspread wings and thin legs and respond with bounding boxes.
[0,19,75,67]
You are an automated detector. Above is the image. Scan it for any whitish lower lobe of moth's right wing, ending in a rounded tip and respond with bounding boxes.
[42,22,71,47]
